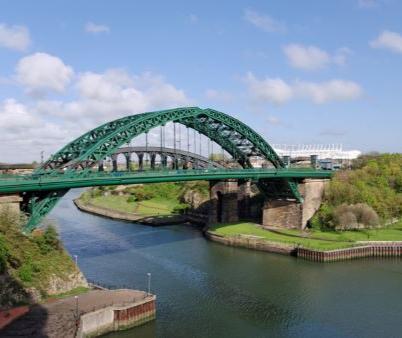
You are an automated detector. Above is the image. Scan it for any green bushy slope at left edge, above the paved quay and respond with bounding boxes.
[0,210,77,305]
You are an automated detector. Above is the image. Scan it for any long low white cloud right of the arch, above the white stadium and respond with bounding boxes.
[245,73,363,104]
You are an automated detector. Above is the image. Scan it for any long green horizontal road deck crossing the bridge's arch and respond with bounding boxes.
[0,168,333,194]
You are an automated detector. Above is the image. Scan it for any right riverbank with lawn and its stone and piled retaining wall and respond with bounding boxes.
[209,223,402,262]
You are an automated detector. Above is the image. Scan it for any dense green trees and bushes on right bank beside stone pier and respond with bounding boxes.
[311,154,402,228]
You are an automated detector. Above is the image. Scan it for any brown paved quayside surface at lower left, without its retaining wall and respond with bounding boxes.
[0,289,147,338]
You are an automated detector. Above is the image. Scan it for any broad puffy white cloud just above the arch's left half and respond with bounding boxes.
[38,69,191,129]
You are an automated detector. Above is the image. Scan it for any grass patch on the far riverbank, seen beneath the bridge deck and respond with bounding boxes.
[89,195,180,215]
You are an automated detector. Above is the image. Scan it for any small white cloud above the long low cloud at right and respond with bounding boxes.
[283,44,351,70]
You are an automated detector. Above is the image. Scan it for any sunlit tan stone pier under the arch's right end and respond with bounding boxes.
[262,179,329,229]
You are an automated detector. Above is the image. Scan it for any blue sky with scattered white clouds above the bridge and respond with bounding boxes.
[0,0,402,162]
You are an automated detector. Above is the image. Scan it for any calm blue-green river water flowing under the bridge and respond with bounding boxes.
[50,190,402,338]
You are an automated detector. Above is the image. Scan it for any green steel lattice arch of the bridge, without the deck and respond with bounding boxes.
[23,107,301,229]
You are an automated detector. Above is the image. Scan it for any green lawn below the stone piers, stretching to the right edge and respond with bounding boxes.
[210,222,402,250]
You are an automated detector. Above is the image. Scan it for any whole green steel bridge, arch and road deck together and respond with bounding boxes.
[0,107,331,231]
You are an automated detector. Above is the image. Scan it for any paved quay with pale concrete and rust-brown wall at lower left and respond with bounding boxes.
[1,289,156,338]
